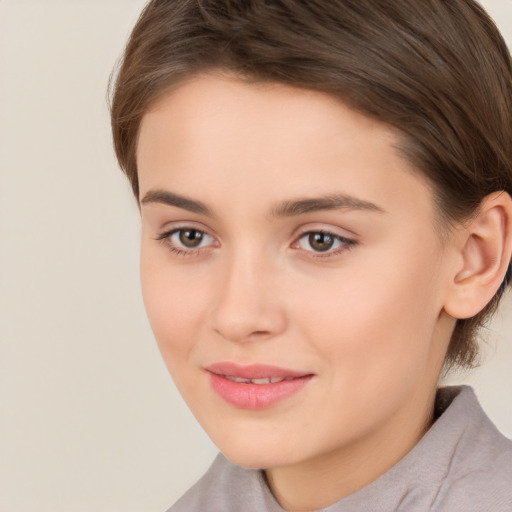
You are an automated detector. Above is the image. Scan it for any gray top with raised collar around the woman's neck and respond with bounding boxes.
[168,386,512,512]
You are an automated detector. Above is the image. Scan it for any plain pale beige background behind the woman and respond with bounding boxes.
[0,0,512,512]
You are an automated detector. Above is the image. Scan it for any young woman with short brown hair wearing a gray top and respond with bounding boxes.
[112,0,512,512]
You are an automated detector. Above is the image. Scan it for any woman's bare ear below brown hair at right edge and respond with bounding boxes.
[444,192,512,319]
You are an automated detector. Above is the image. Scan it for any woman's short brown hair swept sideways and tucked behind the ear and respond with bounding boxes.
[111,0,512,367]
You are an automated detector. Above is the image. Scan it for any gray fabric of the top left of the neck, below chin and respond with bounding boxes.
[167,453,267,512]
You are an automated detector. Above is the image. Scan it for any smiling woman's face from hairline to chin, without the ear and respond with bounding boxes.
[138,75,453,468]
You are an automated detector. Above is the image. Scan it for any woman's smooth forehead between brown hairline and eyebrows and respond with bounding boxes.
[137,75,432,222]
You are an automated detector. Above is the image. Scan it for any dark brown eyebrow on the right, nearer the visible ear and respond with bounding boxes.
[271,194,385,218]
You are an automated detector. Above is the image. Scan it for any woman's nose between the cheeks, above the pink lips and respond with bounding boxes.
[210,249,287,342]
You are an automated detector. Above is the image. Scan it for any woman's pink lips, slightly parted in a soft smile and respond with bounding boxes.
[206,363,313,409]
